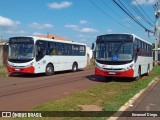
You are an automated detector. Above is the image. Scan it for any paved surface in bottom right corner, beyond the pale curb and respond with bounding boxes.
[117,79,160,120]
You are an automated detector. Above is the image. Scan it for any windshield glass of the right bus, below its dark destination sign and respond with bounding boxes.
[96,41,133,61]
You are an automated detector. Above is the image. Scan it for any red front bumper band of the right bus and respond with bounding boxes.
[95,68,134,77]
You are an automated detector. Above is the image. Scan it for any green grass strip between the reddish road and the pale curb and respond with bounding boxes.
[15,66,160,120]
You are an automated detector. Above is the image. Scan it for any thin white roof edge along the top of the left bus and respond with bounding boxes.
[11,36,86,46]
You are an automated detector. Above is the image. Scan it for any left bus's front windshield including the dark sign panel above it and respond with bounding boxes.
[8,38,34,60]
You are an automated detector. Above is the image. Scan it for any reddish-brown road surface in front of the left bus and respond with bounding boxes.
[0,68,105,111]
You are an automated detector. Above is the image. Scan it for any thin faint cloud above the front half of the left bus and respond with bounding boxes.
[28,23,53,29]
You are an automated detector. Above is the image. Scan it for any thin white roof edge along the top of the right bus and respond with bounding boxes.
[99,33,152,45]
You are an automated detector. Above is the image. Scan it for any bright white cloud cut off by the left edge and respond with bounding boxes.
[0,16,20,27]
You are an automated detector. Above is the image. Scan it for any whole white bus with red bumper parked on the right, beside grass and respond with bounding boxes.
[95,34,153,79]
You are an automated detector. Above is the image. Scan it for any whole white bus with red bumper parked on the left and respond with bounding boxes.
[7,37,87,75]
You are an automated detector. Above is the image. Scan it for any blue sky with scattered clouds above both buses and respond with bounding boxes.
[0,0,158,46]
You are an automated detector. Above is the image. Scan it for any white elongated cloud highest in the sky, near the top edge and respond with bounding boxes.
[48,1,73,9]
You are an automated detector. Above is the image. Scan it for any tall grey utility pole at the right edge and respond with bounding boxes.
[155,0,159,65]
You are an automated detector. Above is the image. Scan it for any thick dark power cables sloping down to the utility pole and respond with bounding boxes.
[113,0,154,33]
